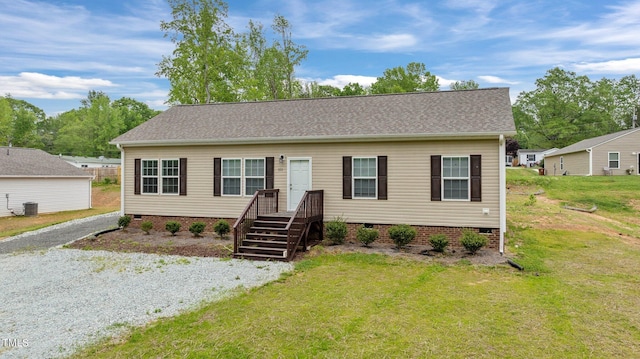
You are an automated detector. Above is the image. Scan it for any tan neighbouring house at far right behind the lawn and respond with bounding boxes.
[544,128,640,176]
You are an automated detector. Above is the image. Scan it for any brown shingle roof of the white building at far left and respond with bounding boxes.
[0,147,91,177]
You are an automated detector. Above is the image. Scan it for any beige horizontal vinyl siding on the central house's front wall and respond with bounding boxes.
[123,139,501,228]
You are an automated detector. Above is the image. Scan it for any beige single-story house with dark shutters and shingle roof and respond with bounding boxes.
[111,88,516,256]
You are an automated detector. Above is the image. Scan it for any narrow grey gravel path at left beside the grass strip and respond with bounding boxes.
[0,212,120,254]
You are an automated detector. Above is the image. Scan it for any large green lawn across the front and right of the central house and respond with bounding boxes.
[65,169,640,358]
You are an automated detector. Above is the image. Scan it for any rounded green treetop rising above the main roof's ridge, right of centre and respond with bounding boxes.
[371,62,439,94]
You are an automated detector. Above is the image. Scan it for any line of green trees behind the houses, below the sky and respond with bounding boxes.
[0,0,640,157]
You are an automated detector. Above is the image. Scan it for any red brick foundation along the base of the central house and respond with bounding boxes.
[121,215,500,251]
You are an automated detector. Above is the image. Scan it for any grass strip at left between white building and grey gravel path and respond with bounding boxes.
[0,183,120,240]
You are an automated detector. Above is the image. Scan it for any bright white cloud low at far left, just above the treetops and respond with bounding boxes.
[0,72,116,100]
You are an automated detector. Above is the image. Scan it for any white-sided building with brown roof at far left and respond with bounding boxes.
[0,147,91,217]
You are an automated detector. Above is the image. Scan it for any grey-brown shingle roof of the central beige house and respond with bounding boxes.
[112,88,515,145]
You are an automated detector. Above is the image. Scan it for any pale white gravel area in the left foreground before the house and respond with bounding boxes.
[0,215,293,359]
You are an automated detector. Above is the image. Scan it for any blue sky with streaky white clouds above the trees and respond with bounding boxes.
[0,0,640,115]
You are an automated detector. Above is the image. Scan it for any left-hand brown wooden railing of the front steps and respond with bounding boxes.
[233,189,280,253]
